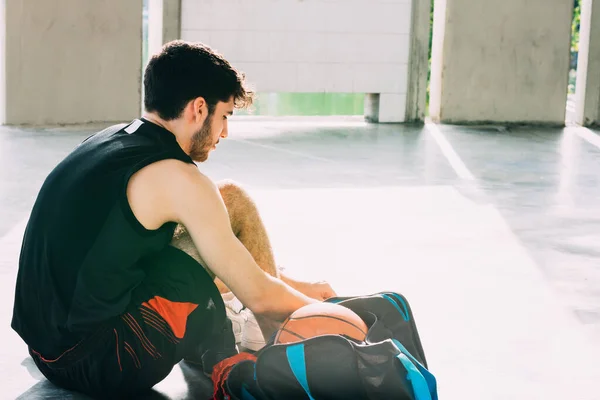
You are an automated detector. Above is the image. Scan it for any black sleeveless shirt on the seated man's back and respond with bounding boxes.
[12,119,193,358]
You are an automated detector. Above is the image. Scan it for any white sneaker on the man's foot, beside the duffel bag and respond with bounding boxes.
[222,292,265,351]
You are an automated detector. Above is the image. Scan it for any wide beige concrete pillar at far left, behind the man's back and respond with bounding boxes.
[0,0,142,125]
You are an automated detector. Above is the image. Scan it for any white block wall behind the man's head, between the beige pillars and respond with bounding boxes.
[181,0,418,122]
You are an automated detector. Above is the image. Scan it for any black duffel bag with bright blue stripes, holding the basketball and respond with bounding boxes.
[221,292,438,400]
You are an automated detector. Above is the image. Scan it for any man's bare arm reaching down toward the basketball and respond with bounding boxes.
[159,163,315,321]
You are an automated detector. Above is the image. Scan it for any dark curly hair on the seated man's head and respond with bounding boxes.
[144,40,254,121]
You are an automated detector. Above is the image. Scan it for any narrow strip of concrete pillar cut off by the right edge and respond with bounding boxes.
[575,0,600,126]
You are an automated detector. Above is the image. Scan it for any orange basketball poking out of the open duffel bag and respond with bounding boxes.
[275,303,367,344]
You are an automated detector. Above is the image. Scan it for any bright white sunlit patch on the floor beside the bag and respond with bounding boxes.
[252,187,600,399]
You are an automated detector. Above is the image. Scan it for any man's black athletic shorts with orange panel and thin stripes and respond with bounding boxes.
[30,246,235,398]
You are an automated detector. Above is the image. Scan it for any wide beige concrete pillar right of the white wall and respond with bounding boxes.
[430,0,573,125]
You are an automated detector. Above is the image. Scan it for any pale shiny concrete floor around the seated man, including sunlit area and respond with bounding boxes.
[0,118,600,400]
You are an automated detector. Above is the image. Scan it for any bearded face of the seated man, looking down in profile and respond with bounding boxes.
[190,99,233,162]
